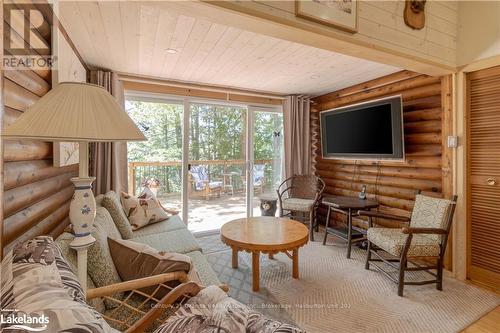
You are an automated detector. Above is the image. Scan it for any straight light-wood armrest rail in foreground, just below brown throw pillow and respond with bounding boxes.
[87,271,188,300]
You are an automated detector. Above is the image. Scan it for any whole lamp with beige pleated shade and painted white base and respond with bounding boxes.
[3,82,146,248]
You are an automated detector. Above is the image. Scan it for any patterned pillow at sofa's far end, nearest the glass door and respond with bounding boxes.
[121,192,172,230]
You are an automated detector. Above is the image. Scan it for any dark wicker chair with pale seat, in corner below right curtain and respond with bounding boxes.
[276,175,325,241]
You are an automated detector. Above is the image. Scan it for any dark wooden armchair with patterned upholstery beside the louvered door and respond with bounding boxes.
[358,191,457,296]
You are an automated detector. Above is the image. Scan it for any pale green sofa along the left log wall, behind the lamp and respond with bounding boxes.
[56,191,221,308]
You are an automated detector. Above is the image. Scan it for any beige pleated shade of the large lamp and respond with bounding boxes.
[3,82,146,142]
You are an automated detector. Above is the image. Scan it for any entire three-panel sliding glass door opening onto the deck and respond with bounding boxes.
[126,96,283,232]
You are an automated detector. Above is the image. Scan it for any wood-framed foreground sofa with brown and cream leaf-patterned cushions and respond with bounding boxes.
[0,236,304,333]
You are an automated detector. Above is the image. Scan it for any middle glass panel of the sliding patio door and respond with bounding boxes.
[187,103,247,232]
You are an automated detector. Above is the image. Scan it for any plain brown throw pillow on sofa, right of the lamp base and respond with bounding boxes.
[108,238,191,281]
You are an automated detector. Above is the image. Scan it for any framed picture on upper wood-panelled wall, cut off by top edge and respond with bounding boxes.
[295,0,358,32]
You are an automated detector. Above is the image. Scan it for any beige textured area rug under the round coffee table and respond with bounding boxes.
[199,234,500,333]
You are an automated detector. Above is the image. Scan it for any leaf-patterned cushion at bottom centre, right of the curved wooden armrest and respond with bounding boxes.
[155,286,305,333]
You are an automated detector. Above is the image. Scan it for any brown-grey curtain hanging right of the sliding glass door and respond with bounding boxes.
[283,95,311,178]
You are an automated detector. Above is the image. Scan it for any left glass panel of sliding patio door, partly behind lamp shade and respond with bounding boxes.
[125,97,184,214]
